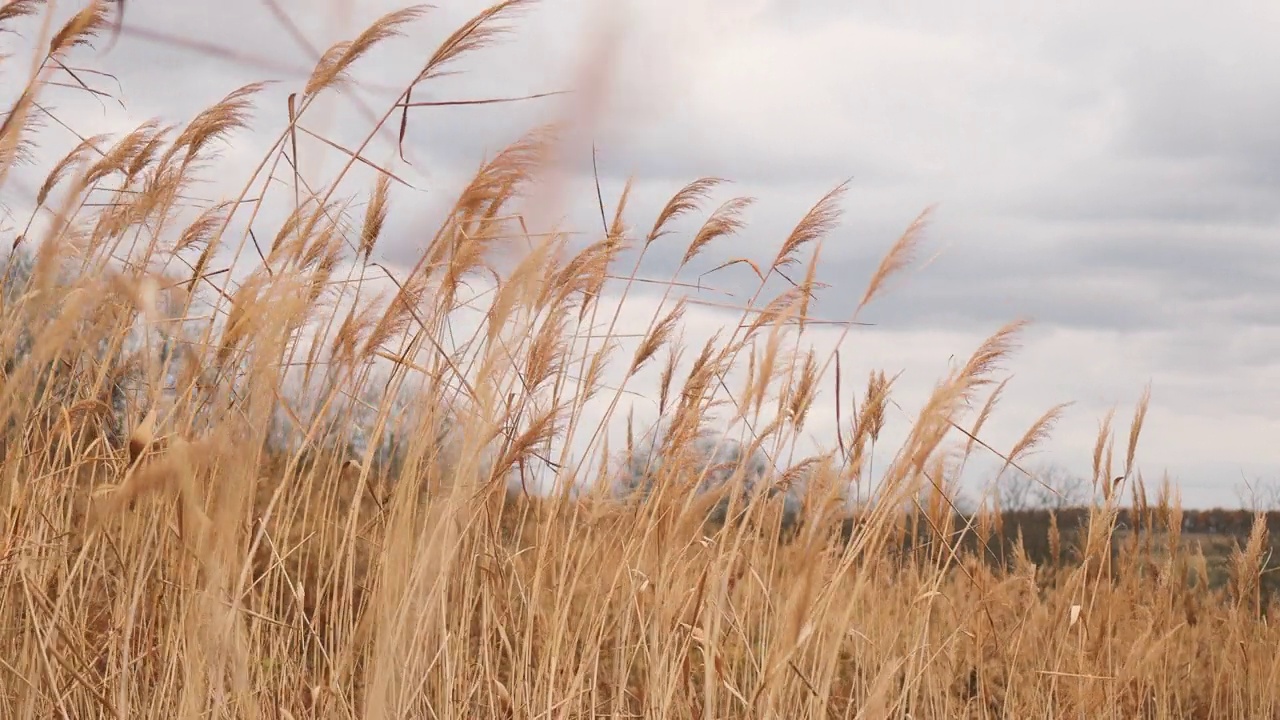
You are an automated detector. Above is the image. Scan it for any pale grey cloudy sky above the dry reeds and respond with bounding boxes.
[5,0,1280,506]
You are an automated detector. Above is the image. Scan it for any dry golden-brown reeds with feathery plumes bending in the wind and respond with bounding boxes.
[0,1,1280,719]
